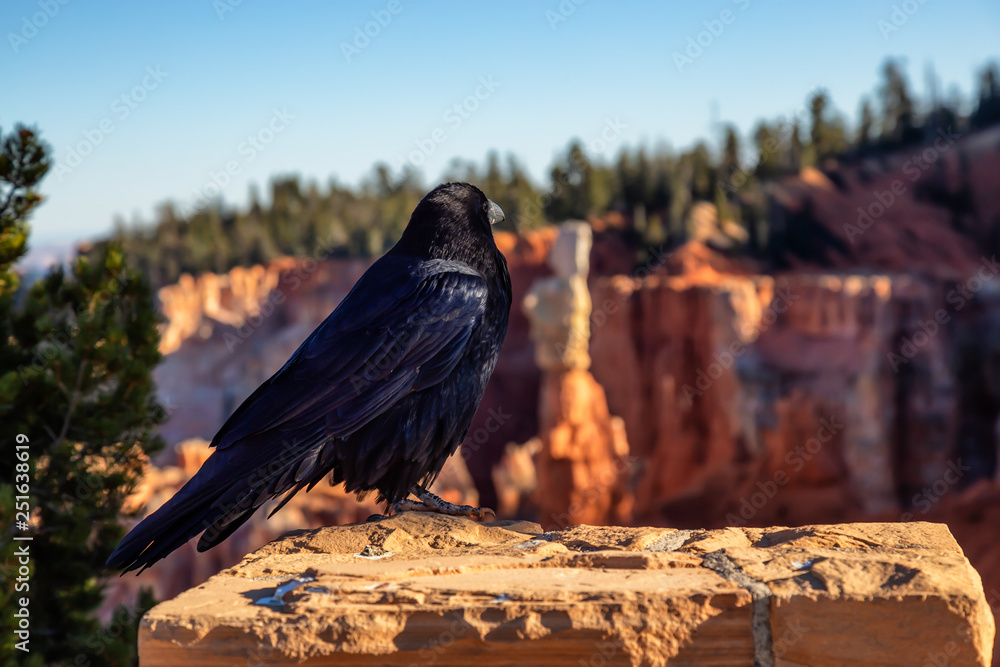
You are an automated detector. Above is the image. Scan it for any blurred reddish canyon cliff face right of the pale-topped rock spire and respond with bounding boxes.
[591,274,1000,525]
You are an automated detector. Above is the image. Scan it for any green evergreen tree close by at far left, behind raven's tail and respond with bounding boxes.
[0,127,162,665]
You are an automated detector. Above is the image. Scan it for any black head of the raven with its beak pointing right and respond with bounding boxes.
[392,183,504,273]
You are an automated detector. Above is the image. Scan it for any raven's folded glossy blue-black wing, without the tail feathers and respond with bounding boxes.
[212,255,487,449]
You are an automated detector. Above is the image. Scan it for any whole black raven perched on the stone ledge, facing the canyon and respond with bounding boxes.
[107,183,511,572]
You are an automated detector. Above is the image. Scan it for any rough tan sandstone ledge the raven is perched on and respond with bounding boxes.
[139,513,994,667]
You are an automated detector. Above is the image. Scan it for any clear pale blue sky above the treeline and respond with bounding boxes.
[0,0,1000,245]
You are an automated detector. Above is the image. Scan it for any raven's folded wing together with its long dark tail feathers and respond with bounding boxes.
[108,255,487,572]
